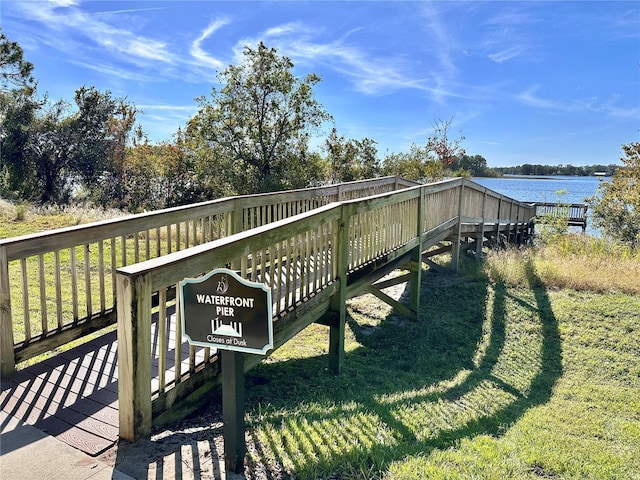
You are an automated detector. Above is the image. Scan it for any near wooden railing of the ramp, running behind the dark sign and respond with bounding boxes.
[116,179,534,441]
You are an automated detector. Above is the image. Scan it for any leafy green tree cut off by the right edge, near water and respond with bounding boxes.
[587,142,640,247]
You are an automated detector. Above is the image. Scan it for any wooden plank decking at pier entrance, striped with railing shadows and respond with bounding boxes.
[0,331,119,456]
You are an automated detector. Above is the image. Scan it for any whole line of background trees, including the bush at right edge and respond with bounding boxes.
[0,31,640,243]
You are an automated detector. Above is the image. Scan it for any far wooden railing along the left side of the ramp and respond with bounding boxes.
[0,177,415,375]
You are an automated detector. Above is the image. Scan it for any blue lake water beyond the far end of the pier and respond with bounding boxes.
[471,176,608,235]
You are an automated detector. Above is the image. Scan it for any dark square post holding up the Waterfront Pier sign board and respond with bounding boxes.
[224,350,246,473]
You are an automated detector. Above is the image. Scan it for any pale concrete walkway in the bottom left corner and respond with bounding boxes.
[0,411,134,480]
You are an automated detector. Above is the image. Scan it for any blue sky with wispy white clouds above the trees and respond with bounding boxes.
[0,0,640,167]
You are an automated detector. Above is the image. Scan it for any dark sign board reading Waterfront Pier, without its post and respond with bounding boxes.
[179,268,273,355]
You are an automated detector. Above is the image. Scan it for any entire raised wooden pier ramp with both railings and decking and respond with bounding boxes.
[0,177,535,455]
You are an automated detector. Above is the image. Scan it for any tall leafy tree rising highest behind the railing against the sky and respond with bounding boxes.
[187,43,331,193]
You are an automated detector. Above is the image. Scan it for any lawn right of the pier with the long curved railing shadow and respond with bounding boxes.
[241,252,640,479]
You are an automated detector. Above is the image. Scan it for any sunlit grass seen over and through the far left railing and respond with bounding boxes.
[0,199,182,350]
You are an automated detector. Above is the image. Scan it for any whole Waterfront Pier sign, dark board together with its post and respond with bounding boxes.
[179,268,273,473]
